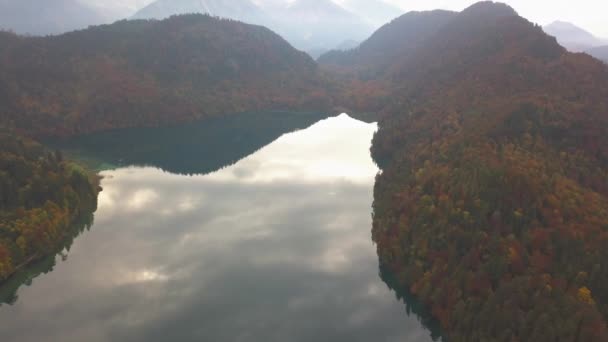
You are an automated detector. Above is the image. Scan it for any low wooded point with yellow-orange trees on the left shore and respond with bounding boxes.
[0,132,99,282]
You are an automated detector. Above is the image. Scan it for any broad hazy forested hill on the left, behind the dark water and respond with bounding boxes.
[0,15,330,135]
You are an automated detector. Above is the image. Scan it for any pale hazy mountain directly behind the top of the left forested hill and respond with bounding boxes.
[132,0,267,25]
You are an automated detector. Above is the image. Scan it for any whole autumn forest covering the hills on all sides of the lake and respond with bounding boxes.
[0,2,608,342]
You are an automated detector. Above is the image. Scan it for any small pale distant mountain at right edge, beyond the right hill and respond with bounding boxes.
[543,21,607,52]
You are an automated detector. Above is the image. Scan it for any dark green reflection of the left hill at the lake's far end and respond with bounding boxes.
[48,112,328,175]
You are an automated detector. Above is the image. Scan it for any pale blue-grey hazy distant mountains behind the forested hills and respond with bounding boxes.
[0,0,608,61]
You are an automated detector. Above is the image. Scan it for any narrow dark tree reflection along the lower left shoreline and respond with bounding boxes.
[0,207,96,306]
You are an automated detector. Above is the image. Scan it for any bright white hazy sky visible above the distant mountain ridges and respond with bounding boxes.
[80,0,608,38]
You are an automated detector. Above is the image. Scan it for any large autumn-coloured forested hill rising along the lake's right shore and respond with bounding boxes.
[372,2,608,341]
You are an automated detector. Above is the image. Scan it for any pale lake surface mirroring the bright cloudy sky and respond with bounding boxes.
[0,115,438,342]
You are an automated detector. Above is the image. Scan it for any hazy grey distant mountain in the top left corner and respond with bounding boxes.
[0,0,106,35]
